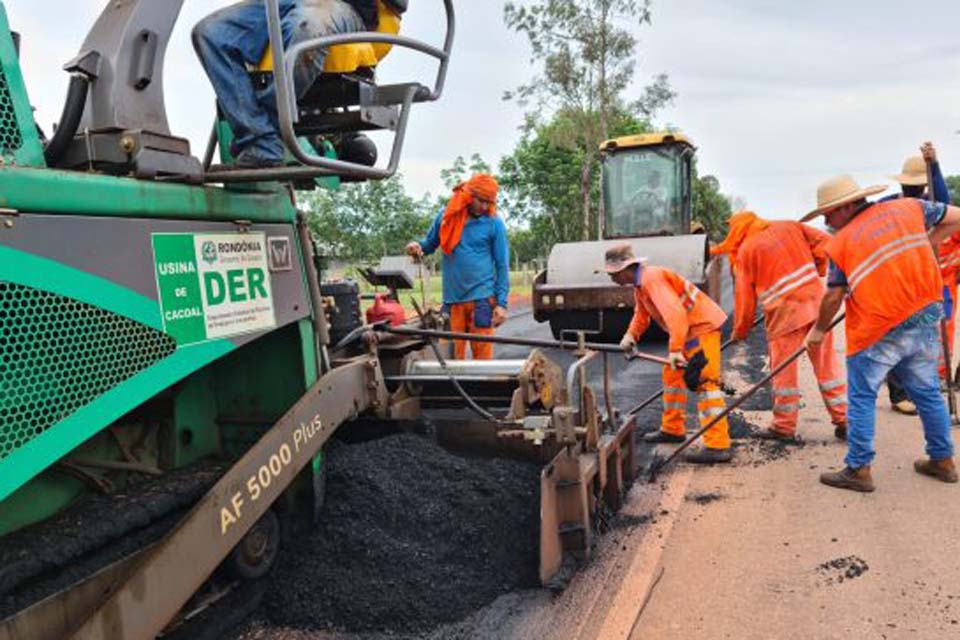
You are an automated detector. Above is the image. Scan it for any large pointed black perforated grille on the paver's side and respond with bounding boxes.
[0,282,176,461]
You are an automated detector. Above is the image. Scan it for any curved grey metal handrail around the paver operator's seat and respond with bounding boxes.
[266,0,456,180]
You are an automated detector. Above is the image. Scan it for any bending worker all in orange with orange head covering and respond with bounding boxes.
[710,211,847,440]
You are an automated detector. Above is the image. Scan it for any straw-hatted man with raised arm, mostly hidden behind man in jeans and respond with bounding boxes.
[881,142,960,415]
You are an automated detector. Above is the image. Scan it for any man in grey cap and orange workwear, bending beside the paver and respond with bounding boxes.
[604,244,733,464]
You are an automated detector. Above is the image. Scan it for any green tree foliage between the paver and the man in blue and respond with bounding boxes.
[300,175,436,263]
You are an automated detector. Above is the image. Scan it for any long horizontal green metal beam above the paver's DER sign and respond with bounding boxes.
[0,167,297,223]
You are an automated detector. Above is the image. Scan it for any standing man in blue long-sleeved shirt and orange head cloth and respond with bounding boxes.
[407,174,510,360]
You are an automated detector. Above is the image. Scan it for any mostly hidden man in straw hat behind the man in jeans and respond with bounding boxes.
[881,142,956,415]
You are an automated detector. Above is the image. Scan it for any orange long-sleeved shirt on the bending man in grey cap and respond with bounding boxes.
[629,265,727,351]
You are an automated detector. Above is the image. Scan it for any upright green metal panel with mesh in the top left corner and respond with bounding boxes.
[0,2,46,167]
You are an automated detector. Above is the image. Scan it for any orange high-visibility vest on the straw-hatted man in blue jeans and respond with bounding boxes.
[827,198,943,356]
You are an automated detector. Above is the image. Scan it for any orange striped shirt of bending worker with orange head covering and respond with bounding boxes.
[733,221,830,338]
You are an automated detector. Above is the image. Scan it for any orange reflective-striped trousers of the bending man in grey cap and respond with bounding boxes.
[660,331,730,449]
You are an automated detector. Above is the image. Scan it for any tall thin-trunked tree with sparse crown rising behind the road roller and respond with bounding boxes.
[504,0,674,240]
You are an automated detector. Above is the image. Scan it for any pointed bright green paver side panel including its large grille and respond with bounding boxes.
[0,246,235,500]
